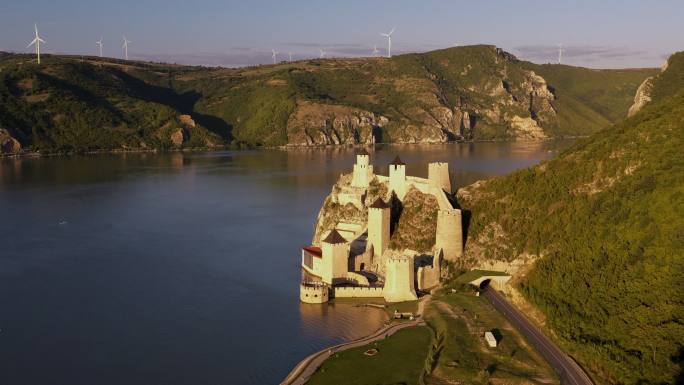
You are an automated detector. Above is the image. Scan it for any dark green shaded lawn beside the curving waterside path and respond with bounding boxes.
[307,326,432,385]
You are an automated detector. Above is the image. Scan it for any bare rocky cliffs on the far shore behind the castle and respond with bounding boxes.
[287,64,557,146]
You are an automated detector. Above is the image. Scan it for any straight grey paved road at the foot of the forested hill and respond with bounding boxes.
[482,286,593,385]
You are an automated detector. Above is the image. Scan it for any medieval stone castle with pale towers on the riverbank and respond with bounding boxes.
[300,153,463,303]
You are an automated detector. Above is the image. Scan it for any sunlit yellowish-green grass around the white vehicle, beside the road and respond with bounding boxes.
[425,292,558,384]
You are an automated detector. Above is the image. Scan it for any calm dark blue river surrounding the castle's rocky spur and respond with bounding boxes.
[0,141,572,385]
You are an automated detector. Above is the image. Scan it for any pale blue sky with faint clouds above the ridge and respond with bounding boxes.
[0,0,684,68]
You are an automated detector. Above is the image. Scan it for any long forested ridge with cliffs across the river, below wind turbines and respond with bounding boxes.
[0,45,657,151]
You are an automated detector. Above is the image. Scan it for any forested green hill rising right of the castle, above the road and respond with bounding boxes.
[459,53,684,384]
